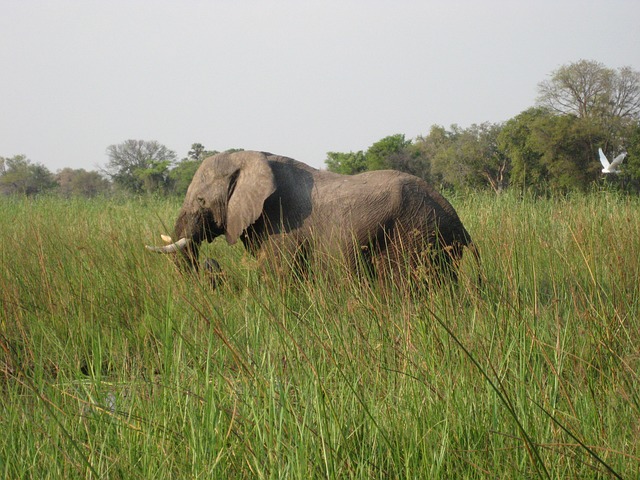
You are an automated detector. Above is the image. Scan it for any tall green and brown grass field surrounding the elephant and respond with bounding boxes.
[0,192,640,480]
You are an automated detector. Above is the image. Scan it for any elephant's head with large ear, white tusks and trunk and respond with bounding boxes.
[147,151,276,267]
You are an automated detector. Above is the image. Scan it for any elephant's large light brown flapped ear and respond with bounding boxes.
[225,152,276,245]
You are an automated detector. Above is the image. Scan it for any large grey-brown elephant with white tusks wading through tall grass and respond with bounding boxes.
[147,150,479,280]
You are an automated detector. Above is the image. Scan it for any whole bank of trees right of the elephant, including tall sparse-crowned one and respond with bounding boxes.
[326,60,640,193]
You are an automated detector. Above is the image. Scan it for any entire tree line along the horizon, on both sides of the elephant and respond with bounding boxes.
[0,60,640,197]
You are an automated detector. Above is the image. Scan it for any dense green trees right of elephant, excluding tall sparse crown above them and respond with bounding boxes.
[326,113,640,193]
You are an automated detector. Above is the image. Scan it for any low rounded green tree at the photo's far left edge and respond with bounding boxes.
[0,155,56,195]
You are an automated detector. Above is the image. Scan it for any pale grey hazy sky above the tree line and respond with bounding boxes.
[0,0,640,172]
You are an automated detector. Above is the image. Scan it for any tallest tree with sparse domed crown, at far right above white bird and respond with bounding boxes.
[530,60,640,189]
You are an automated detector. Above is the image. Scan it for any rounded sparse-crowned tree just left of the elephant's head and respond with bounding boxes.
[105,140,176,193]
